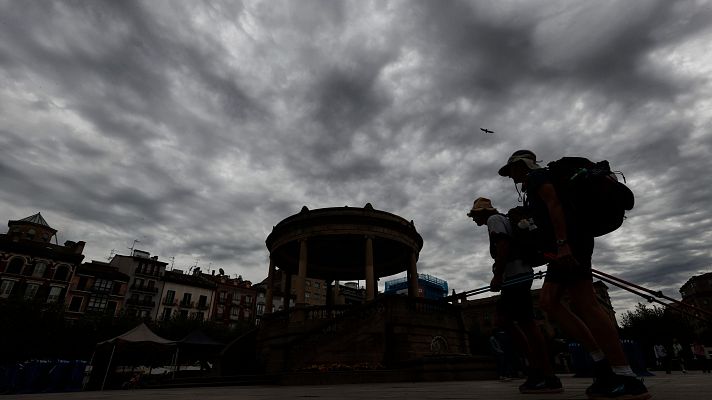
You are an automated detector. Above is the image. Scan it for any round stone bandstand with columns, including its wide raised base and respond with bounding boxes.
[246,203,490,381]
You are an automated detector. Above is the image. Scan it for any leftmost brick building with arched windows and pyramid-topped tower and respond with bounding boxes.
[0,213,85,304]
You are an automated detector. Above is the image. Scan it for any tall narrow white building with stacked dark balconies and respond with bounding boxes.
[109,250,168,318]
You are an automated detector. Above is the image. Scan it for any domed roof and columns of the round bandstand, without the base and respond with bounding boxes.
[265,203,423,313]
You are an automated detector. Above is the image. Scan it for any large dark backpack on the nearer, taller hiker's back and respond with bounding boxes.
[547,157,635,236]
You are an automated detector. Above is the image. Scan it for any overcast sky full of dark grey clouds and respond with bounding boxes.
[0,0,712,315]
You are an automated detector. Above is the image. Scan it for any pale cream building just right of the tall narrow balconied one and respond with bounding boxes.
[154,269,217,321]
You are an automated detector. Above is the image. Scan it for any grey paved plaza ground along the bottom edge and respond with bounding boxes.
[2,372,712,400]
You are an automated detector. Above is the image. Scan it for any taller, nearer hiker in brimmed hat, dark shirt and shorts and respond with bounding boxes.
[499,150,651,400]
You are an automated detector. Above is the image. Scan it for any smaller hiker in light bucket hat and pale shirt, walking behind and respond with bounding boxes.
[467,197,563,393]
